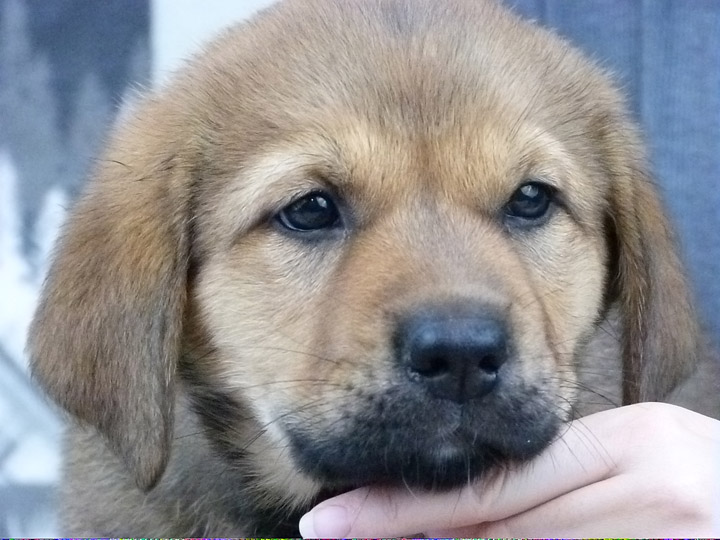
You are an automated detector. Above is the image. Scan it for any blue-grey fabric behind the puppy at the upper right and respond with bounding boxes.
[507,0,720,343]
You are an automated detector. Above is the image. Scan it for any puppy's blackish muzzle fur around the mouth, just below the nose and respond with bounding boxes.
[286,382,562,490]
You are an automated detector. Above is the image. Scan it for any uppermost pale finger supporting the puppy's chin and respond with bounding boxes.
[301,410,617,537]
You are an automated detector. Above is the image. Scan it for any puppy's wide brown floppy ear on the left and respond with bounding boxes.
[28,105,189,489]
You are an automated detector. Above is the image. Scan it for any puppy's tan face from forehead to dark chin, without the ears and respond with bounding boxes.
[187,0,608,486]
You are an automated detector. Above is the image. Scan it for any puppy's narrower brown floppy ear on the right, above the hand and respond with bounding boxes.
[609,160,699,404]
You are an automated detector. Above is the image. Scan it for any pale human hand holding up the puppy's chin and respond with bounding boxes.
[300,403,720,538]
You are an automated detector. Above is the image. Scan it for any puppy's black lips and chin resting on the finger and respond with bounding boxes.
[285,394,560,490]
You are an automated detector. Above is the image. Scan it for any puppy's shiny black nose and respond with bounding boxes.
[396,312,508,403]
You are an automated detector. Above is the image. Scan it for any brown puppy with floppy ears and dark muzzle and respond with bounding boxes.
[29,0,716,536]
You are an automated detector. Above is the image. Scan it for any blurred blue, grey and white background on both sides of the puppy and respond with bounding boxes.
[0,0,720,537]
